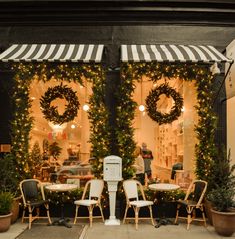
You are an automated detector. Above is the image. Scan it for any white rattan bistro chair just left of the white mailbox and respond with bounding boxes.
[74,179,104,227]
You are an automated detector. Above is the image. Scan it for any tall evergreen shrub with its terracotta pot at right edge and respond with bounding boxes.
[207,150,235,236]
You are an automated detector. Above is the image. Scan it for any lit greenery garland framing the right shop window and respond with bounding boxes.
[120,62,217,181]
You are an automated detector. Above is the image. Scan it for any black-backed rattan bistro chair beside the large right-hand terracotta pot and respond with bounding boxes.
[175,180,207,230]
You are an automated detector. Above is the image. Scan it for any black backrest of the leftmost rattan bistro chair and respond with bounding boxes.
[20,179,45,204]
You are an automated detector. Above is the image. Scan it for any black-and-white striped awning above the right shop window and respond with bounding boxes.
[121,45,233,63]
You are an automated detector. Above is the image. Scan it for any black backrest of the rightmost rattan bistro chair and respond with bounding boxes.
[185,180,207,205]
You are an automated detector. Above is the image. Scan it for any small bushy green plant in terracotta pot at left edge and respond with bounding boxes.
[0,192,13,232]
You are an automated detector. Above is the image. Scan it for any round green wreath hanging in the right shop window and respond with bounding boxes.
[145,84,183,125]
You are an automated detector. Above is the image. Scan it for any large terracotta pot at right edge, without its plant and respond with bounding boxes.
[211,209,235,237]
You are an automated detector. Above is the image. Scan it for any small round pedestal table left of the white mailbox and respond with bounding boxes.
[45,184,78,228]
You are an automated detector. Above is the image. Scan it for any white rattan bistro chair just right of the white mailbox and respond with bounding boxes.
[123,179,154,229]
